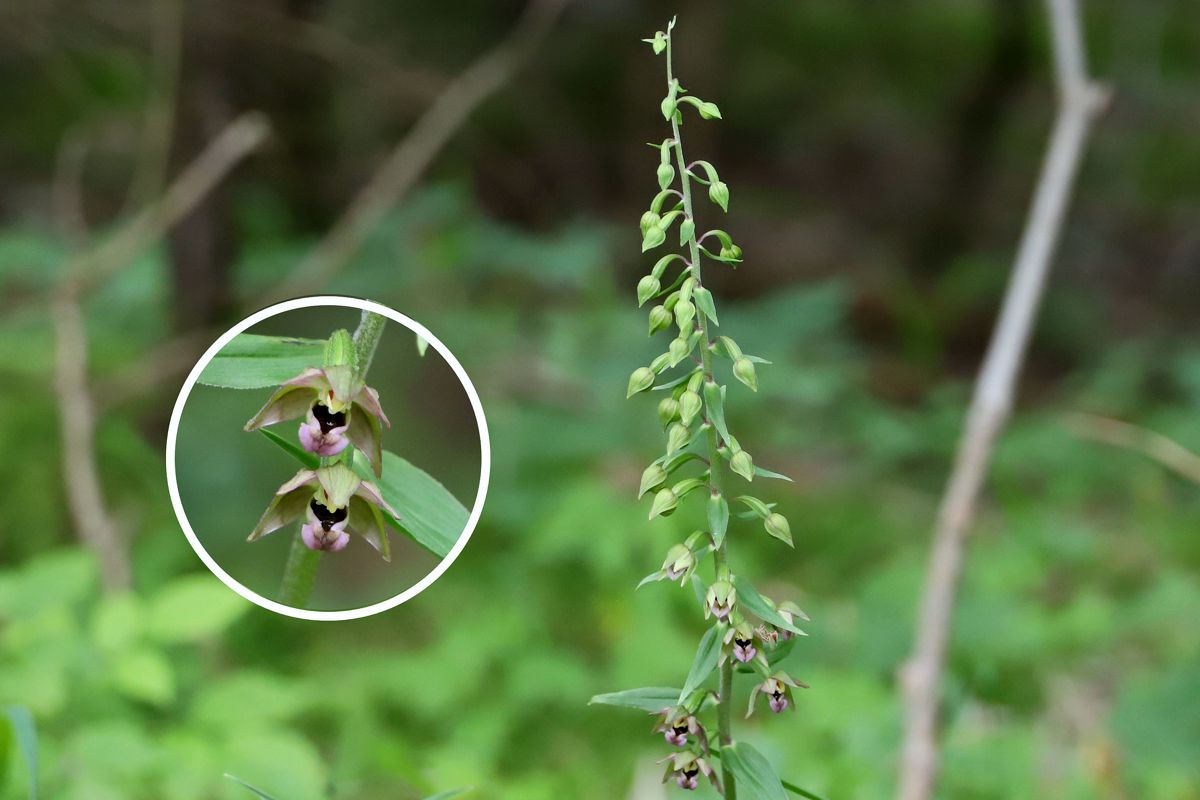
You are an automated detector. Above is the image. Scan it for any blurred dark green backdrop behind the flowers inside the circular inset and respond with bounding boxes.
[175,306,480,609]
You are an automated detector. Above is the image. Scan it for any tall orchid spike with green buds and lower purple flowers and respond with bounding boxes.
[593,19,811,800]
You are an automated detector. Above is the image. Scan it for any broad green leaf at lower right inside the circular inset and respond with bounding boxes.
[354,450,470,558]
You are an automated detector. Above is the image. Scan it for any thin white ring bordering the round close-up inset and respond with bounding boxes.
[167,295,492,621]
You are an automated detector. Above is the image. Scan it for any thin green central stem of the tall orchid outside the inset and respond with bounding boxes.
[666,30,738,800]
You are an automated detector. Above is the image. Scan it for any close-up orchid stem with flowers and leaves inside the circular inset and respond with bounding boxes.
[199,311,468,608]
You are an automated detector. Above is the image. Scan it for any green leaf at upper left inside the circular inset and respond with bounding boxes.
[197,333,325,389]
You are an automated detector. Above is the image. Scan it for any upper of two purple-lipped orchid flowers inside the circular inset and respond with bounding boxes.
[246,366,391,475]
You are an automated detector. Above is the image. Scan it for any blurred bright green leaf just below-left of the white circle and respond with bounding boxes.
[148,573,250,644]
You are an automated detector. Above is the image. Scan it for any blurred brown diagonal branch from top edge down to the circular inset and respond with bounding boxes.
[264,0,566,302]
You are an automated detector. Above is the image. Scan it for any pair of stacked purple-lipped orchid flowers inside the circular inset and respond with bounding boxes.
[245,330,397,560]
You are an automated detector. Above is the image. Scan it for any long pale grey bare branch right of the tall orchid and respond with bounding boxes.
[896,0,1106,800]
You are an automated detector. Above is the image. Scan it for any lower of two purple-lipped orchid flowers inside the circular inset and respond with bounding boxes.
[248,464,400,561]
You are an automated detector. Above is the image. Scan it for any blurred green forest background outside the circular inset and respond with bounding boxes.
[0,0,1200,800]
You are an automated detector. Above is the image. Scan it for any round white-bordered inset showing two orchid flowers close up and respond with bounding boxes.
[167,295,491,620]
